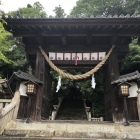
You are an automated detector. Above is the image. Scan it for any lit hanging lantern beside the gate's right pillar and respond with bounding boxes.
[119,82,131,97]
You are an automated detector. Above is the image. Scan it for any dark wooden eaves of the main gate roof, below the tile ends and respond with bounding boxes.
[4,18,140,36]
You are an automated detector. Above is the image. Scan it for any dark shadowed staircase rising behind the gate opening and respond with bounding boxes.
[56,97,87,120]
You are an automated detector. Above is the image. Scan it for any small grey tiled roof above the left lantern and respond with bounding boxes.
[9,70,43,84]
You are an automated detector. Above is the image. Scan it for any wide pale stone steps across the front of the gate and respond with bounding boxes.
[3,121,140,140]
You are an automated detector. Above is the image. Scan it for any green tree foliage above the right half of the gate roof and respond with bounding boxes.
[71,0,140,16]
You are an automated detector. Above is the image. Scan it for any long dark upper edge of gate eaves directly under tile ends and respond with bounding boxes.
[5,18,140,26]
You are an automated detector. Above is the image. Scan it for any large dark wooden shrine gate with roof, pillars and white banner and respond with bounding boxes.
[3,15,140,122]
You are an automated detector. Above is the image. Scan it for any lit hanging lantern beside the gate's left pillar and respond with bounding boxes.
[26,82,36,94]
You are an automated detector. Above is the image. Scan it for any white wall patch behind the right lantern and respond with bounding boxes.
[128,82,138,98]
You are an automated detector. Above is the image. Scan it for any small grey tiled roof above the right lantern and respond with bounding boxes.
[111,71,140,84]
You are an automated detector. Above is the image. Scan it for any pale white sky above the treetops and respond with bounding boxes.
[0,0,78,16]
